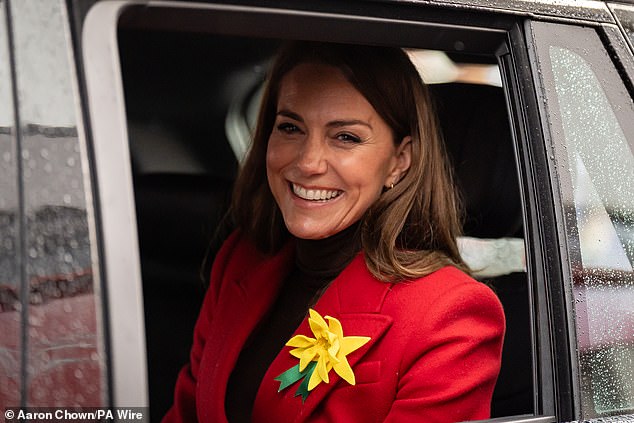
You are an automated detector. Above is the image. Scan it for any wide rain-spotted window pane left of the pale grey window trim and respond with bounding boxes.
[10,0,106,406]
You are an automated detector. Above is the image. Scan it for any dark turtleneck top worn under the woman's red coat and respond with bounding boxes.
[225,224,360,423]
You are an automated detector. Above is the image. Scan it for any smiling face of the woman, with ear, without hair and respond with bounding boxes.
[266,63,411,239]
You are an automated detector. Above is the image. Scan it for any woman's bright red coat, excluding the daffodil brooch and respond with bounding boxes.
[164,233,504,423]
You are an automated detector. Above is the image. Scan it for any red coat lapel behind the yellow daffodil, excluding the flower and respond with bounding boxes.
[253,254,392,422]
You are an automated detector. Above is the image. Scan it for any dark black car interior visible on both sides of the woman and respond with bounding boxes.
[118,19,534,421]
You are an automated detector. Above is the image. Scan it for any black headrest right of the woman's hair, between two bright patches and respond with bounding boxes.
[429,84,523,238]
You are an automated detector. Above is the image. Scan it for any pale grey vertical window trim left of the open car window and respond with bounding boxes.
[82,0,148,407]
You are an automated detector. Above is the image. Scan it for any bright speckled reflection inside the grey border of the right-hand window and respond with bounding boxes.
[550,47,634,418]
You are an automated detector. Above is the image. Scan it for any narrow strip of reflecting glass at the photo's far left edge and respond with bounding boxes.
[0,0,21,406]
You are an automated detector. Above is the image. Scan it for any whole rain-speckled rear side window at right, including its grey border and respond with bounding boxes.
[535,25,634,419]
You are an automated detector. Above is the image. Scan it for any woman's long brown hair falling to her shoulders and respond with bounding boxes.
[231,41,468,281]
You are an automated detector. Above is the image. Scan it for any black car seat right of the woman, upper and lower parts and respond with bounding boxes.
[429,83,534,417]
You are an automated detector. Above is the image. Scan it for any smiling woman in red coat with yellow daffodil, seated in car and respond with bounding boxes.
[165,42,504,422]
